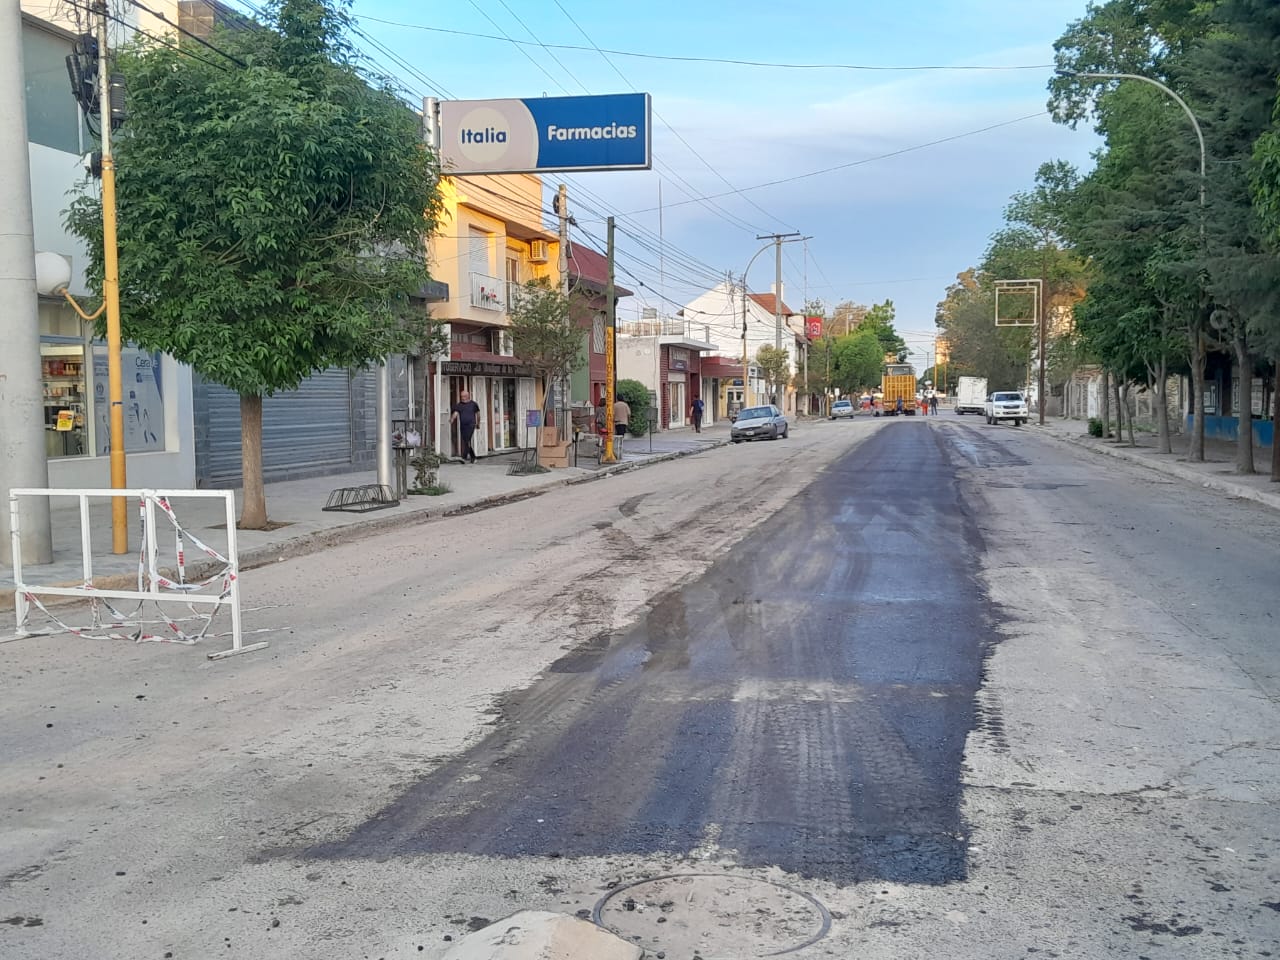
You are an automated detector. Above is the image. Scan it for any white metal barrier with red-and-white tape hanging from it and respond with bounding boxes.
[0,488,266,659]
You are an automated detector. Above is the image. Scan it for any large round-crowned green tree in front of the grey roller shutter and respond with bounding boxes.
[68,0,440,529]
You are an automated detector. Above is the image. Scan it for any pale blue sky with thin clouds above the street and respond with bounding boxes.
[317,0,1098,370]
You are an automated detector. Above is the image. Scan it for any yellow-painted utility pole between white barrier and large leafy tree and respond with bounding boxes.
[95,0,129,553]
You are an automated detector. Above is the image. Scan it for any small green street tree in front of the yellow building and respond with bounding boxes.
[507,279,584,463]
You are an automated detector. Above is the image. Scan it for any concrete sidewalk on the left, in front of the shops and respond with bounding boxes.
[0,424,728,599]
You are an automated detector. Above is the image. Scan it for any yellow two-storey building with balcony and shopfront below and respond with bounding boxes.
[429,174,559,456]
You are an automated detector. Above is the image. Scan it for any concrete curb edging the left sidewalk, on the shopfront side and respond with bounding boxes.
[0,439,728,611]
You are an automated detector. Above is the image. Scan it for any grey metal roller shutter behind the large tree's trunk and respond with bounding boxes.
[202,367,352,486]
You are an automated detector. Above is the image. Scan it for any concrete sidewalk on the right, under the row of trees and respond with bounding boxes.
[1021,419,1280,509]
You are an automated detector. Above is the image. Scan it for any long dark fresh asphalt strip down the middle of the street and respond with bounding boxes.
[308,422,995,884]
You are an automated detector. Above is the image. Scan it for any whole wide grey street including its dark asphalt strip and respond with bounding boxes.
[0,417,1280,960]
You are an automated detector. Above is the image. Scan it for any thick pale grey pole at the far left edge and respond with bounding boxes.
[0,3,54,563]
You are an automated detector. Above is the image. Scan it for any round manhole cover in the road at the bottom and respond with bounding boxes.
[594,873,831,960]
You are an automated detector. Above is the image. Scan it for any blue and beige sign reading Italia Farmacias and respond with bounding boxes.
[439,93,652,174]
